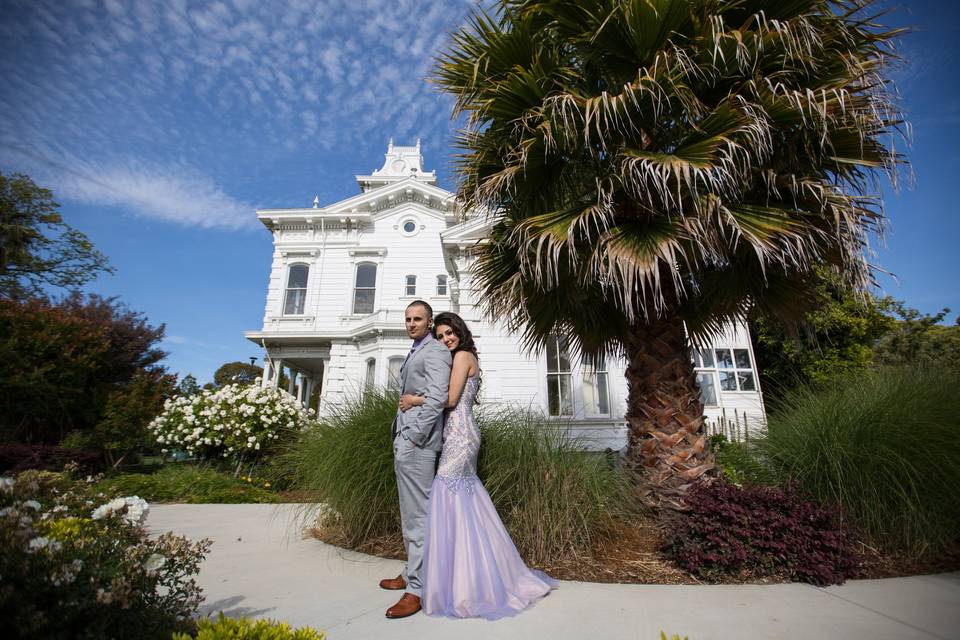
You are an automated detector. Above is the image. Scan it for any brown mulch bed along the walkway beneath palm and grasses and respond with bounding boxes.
[308,520,960,584]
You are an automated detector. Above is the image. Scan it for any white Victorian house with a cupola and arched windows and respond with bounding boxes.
[245,141,764,449]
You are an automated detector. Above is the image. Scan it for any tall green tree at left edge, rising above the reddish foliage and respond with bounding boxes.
[0,173,112,298]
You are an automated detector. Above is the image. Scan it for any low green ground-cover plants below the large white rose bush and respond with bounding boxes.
[99,464,278,504]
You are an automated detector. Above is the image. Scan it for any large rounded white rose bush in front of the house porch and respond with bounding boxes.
[148,384,314,463]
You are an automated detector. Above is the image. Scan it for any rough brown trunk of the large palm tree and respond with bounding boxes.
[625,315,715,508]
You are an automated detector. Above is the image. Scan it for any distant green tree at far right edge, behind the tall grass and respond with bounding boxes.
[874,297,960,367]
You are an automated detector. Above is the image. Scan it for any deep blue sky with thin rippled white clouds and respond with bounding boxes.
[0,0,960,382]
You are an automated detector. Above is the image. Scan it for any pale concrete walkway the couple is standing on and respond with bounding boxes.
[148,505,960,640]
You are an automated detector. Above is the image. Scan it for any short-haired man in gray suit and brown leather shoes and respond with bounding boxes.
[380,300,453,618]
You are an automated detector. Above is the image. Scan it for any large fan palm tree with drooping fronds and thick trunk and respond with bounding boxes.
[433,0,905,505]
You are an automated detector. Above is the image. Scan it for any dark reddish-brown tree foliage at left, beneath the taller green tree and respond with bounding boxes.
[0,293,174,458]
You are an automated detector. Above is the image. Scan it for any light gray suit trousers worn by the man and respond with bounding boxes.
[393,435,437,597]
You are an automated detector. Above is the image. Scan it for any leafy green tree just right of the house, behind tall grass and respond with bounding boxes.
[749,269,894,404]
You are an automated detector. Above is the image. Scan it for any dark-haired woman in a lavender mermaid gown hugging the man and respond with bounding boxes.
[400,313,556,620]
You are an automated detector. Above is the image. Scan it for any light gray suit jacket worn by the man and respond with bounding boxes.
[390,333,453,451]
